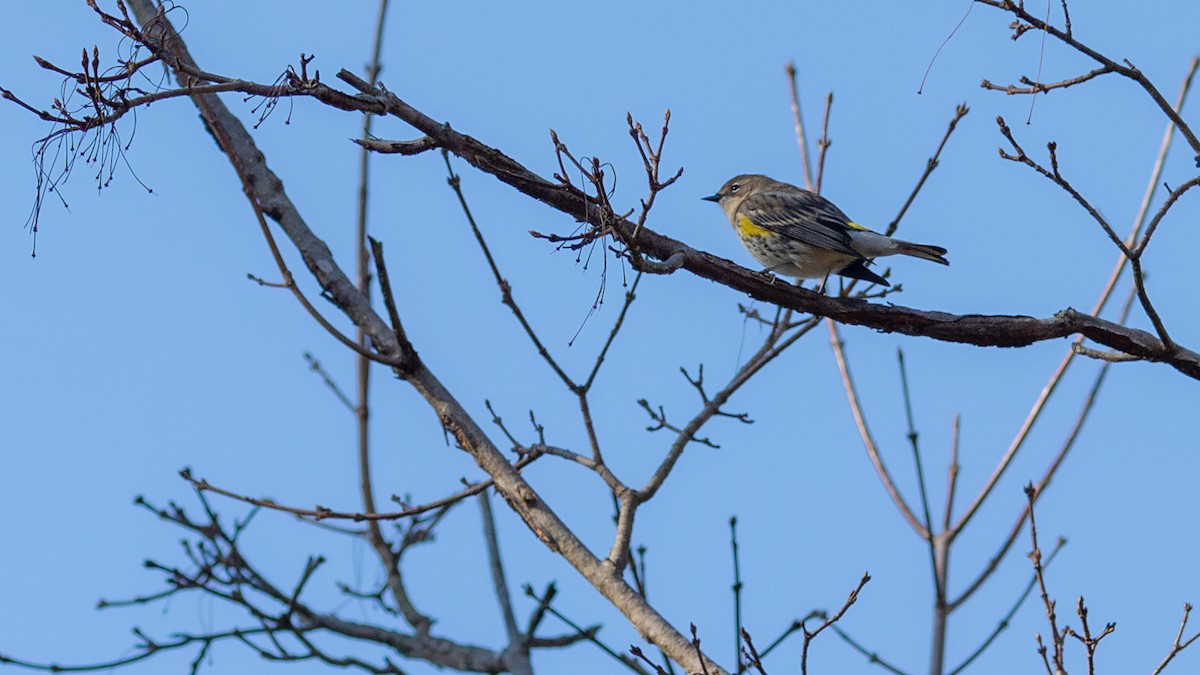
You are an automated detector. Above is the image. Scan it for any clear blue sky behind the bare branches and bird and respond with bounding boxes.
[0,0,1200,673]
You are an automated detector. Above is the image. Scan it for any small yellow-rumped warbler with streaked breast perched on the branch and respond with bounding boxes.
[704,174,950,286]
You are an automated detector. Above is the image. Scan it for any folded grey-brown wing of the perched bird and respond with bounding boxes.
[740,192,863,258]
